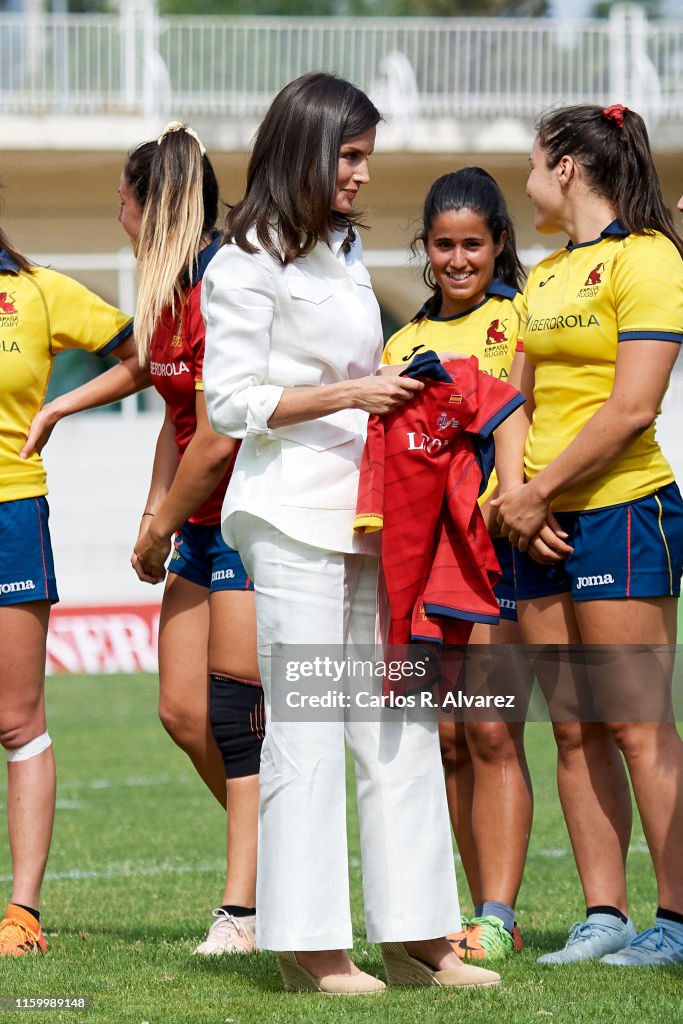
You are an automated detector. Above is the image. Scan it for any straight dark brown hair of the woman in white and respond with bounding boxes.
[223,72,382,264]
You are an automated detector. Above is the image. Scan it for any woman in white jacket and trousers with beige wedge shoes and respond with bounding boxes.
[203,73,500,994]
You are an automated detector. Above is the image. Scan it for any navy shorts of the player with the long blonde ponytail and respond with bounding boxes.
[168,522,254,594]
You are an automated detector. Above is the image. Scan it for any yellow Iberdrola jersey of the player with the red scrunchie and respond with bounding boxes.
[521,221,683,511]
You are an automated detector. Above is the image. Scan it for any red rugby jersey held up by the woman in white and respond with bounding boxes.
[355,357,524,644]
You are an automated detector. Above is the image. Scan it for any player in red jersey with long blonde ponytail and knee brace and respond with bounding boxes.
[23,123,263,953]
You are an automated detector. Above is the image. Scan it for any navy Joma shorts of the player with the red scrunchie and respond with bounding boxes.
[514,483,683,601]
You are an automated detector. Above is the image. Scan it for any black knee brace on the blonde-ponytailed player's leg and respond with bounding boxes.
[209,672,265,778]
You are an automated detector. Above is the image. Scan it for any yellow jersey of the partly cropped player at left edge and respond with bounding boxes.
[0,251,133,502]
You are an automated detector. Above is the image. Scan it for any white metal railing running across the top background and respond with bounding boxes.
[0,5,683,121]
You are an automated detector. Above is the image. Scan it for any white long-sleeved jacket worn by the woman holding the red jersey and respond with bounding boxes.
[202,232,383,553]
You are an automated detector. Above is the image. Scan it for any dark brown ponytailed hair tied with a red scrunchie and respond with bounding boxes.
[537,104,683,256]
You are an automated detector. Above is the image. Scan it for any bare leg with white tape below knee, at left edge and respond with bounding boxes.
[0,601,55,909]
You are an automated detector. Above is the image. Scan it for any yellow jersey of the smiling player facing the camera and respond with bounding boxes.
[382,280,522,505]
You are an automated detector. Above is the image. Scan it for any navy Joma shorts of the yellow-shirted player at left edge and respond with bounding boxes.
[0,497,59,604]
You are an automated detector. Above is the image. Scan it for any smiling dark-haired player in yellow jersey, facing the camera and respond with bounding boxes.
[382,167,532,961]
